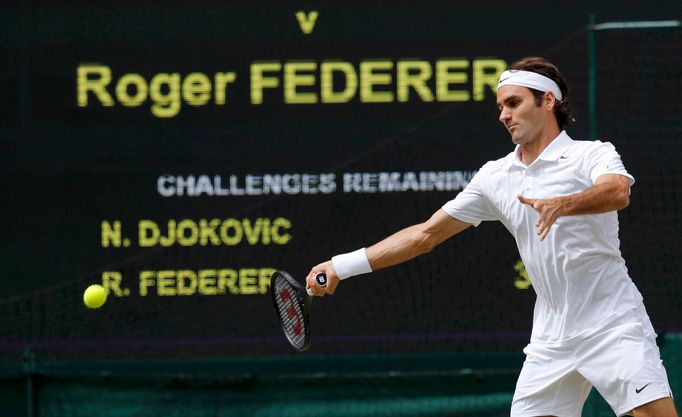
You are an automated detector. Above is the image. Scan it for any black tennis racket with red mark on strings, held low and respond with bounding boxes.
[270,271,327,352]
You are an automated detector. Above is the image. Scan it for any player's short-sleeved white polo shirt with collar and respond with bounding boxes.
[443,132,642,344]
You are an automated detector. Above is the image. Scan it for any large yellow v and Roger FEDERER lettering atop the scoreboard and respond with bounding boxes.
[77,58,507,113]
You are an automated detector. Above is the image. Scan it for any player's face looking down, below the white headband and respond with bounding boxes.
[497,85,546,145]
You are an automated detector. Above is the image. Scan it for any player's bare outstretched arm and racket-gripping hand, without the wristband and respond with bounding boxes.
[306,209,471,296]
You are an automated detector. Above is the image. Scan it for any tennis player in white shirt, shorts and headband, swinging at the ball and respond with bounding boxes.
[307,57,677,417]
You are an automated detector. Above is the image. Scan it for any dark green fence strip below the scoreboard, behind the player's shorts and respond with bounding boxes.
[0,334,682,417]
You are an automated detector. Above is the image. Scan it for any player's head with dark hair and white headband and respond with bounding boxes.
[497,57,573,144]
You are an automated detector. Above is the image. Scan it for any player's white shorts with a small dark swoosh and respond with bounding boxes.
[511,305,672,417]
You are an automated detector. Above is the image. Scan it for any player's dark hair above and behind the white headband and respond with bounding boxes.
[509,56,575,130]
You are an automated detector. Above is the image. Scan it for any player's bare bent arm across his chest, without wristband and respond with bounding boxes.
[518,174,631,240]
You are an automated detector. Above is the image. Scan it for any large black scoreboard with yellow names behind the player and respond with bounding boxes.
[0,1,680,358]
